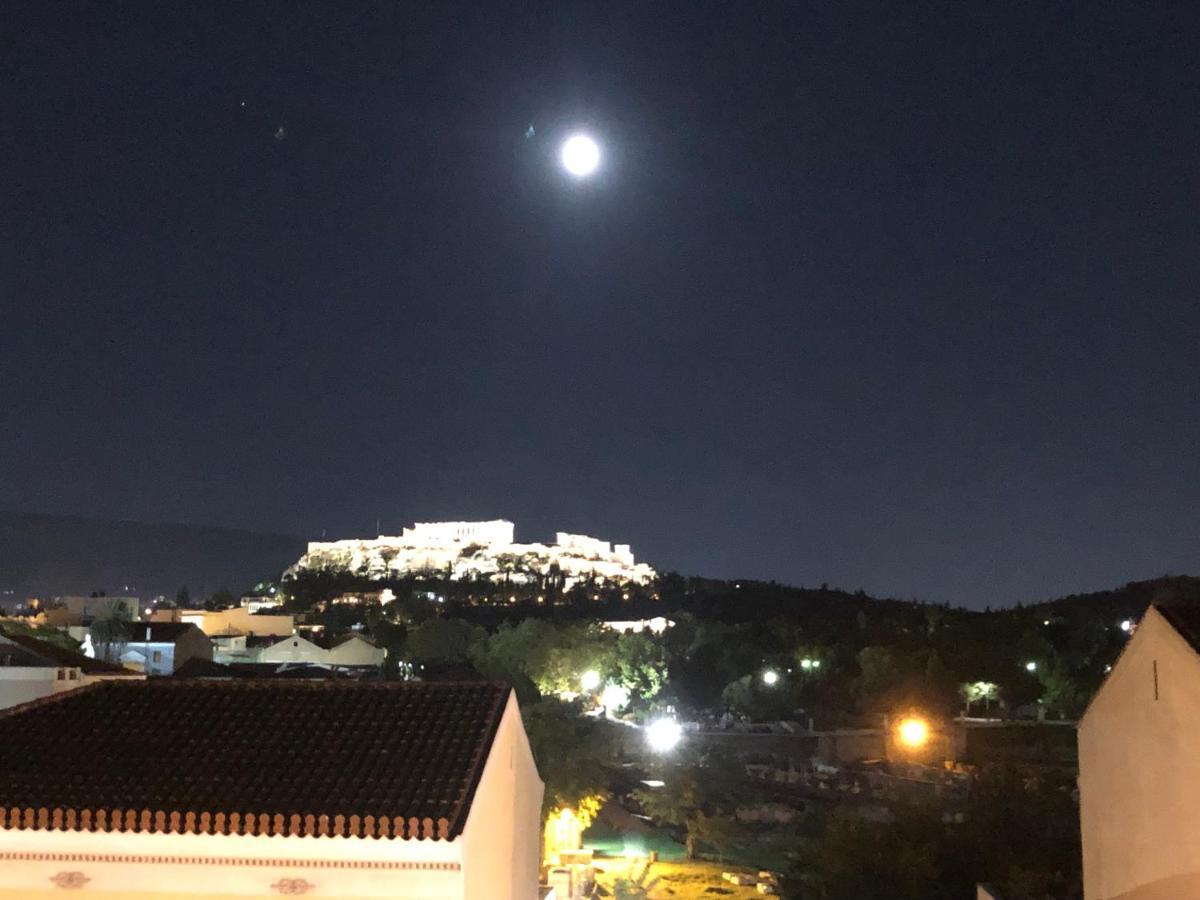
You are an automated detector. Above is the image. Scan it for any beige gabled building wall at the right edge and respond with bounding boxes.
[1079,608,1200,900]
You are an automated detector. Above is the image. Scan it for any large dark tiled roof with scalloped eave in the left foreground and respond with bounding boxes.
[0,679,510,839]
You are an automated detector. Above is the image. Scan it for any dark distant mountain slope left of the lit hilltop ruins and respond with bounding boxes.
[0,511,305,605]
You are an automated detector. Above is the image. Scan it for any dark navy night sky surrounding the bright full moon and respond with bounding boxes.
[0,0,1200,606]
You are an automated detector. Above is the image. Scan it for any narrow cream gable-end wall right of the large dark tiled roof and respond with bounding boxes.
[461,694,545,900]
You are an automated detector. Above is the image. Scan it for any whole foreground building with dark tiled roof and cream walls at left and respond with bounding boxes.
[0,679,542,900]
